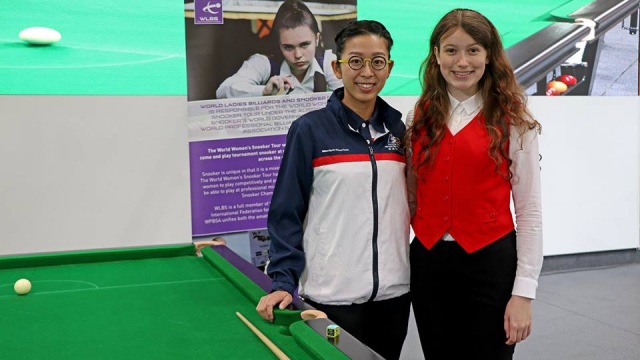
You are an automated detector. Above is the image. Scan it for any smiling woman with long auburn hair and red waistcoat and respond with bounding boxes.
[407,9,542,360]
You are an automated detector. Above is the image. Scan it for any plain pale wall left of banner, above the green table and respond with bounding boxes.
[0,96,191,255]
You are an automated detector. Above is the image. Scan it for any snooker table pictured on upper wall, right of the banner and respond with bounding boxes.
[358,0,639,95]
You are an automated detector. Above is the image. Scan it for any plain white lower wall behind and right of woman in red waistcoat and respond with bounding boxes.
[385,96,640,255]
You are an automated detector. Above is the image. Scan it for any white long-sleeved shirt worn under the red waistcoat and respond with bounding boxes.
[406,93,543,299]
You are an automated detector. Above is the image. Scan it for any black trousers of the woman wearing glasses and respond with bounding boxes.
[305,294,411,360]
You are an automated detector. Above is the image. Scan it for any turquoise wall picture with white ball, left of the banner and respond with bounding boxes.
[0,0,187,95]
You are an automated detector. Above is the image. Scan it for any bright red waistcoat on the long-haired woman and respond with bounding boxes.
[411,115,514,253]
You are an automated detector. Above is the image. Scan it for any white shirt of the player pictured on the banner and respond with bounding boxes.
[216,50,342,99]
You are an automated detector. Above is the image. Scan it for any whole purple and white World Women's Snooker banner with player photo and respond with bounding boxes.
[185,0,356,236]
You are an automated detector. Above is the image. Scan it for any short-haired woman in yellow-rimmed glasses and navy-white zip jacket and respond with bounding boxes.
[257,20,410,359]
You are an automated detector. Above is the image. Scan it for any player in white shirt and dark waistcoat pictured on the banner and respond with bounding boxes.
[216,0,342,99]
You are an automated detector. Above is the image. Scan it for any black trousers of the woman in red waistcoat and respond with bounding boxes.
[410,231,517,360]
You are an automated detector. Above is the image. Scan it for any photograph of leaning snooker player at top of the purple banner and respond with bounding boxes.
[185,0,356,101]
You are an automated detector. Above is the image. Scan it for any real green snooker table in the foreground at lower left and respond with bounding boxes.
[0,244,380,360]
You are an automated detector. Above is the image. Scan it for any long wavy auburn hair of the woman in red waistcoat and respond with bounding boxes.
[405,9,541,177]
